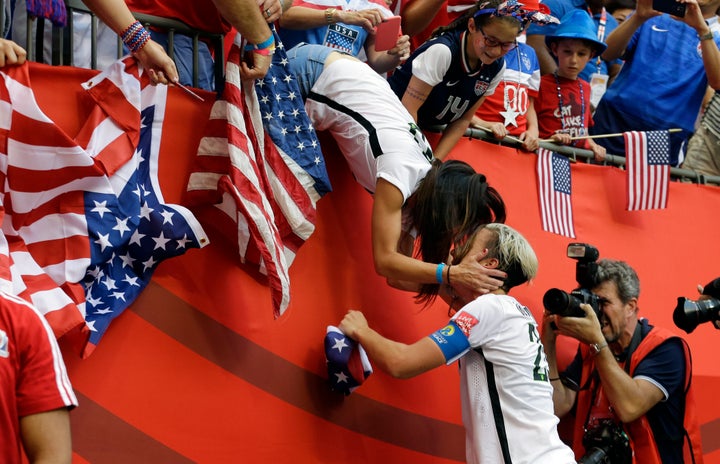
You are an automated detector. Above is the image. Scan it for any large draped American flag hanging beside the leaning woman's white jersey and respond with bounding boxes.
[188,29,330,316]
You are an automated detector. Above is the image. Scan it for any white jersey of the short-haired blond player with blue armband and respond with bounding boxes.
[458,295,575,464]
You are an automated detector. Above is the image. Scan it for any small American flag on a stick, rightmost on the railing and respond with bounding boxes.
[623,131,670,211]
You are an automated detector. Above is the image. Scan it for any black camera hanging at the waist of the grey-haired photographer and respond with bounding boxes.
[578,419,632,464]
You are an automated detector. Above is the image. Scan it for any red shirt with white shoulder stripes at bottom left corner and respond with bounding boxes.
[0,292,77,464]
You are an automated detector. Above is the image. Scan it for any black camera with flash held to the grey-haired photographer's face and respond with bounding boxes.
[543,243,600,319]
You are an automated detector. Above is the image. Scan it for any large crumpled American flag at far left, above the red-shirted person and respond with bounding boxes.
[0,58,207,356]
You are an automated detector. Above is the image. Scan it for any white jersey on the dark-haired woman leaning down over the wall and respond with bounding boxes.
[305,59,432,200]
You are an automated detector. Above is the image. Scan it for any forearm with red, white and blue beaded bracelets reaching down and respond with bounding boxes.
[80,0,178,84]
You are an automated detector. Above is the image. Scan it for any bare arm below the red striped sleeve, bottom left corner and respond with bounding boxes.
[20,408,72,464]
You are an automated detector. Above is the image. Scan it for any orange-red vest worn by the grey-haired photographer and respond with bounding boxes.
[573,327,703,464]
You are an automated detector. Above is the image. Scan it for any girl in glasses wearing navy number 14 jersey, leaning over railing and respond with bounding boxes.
[388,0,547,160]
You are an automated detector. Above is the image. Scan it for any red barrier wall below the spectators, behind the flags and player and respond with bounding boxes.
[25,65,720,464]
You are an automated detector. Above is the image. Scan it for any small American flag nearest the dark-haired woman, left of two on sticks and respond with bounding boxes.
[537,148,575,238]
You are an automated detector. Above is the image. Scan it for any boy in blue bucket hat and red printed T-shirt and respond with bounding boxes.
[536,10,607,161]
